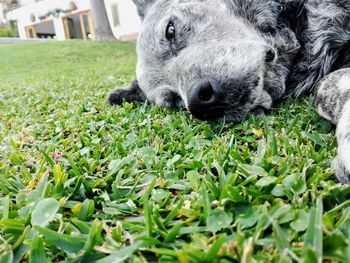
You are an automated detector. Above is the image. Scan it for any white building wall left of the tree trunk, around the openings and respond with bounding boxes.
[8,0,90,40]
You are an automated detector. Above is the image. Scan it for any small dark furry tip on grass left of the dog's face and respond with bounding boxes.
[108,80,146,105]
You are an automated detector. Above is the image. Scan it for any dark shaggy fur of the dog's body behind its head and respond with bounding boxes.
[287,0,350,96]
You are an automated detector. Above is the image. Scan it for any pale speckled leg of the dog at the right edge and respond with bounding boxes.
[316,68,350,184]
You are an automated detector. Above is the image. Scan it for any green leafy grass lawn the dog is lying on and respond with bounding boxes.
[0,42,350,263]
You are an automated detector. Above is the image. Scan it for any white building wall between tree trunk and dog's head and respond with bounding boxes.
[104,0,141,39]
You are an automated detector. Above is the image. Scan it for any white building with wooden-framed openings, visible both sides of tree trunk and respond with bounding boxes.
[7,0,140,40]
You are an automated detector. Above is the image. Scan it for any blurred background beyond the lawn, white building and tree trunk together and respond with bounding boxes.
[0,0,140,42]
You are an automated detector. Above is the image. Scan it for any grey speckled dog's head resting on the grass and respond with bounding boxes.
[109,0,296,121]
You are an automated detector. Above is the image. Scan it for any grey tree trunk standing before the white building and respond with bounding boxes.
[90,0,115,41]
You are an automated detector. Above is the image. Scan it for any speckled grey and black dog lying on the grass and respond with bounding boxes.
[108,0,350,182]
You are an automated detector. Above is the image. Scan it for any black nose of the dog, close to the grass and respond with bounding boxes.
[188,81,225,120]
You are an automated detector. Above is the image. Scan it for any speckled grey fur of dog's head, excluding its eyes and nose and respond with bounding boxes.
[109,0,304,121]
